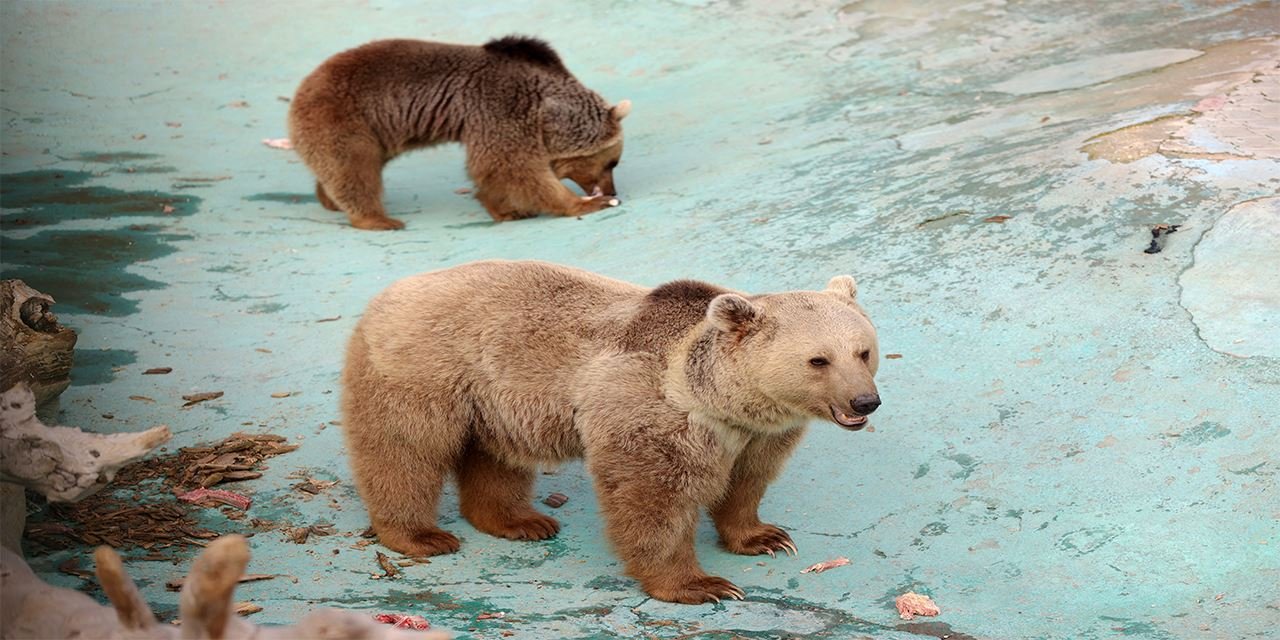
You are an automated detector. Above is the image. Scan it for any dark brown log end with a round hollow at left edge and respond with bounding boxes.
[0,280,76,407]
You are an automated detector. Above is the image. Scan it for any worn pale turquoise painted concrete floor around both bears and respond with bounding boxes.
[0,0,1280,639]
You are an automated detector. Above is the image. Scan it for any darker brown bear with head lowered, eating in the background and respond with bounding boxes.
[289,36,631,229]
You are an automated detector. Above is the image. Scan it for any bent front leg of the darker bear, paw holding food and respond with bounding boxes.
[467,157,620,221]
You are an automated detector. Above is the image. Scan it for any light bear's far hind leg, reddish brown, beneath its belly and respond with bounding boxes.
[457,440,559,540]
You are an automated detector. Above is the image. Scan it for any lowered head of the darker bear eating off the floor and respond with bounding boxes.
[543,99,631,196]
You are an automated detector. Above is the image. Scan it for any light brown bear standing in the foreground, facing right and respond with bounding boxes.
[342,261,879,604]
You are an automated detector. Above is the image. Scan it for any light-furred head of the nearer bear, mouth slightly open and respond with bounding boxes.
[685,275,881,431]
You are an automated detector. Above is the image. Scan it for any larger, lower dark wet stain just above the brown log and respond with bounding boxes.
[0,227,191,316]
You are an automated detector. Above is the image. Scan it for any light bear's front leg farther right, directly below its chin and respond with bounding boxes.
[710,429,804,556]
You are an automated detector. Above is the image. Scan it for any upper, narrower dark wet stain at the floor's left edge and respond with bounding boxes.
[0,169,200,229]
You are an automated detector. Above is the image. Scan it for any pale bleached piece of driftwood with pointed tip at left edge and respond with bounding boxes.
[0,384,169,502]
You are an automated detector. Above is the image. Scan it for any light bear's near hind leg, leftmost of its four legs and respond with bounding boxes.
[342,328,468,556]
